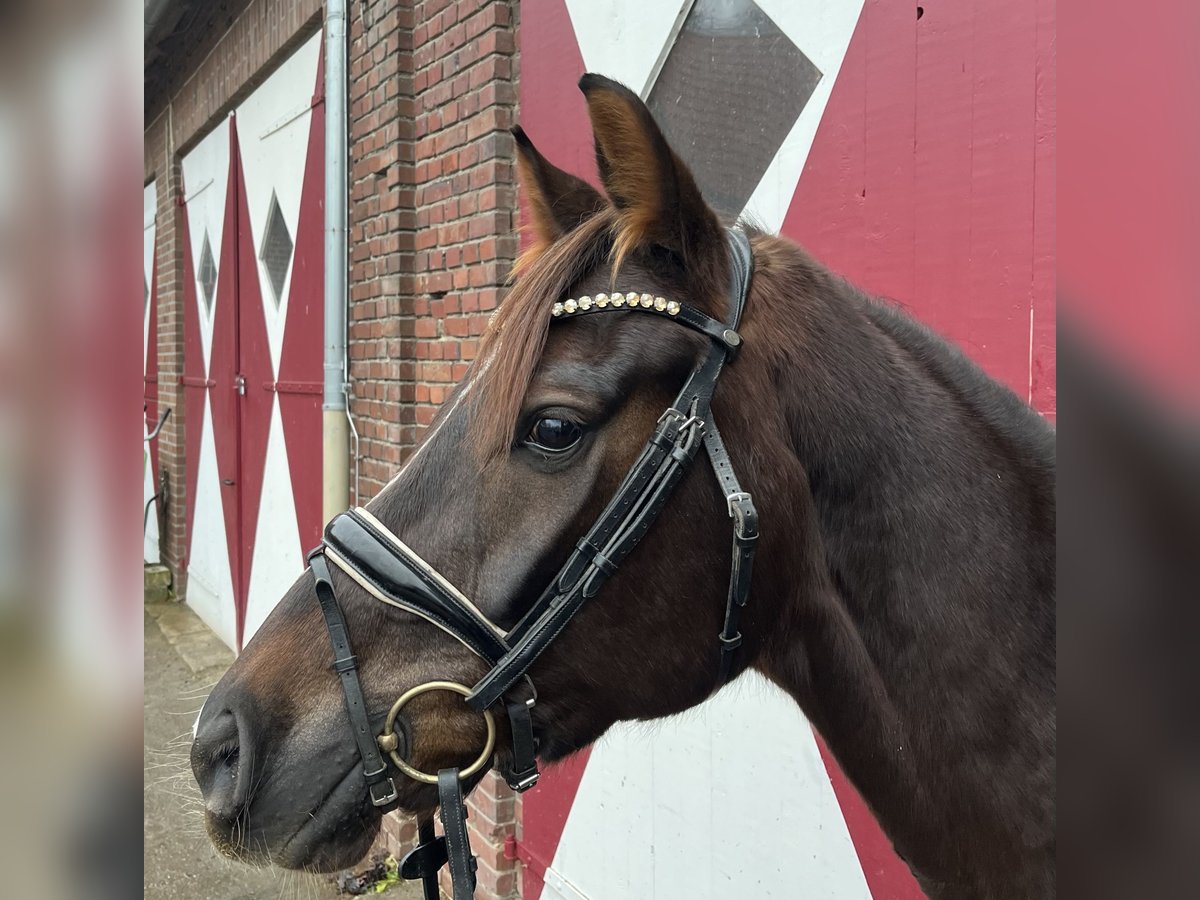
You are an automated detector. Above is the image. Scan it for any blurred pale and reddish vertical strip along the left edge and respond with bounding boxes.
[0,0,142,900]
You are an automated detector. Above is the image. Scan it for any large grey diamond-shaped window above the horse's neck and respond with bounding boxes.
[647,0,821,217]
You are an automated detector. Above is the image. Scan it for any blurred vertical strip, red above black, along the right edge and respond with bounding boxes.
[1057,0,1200,900]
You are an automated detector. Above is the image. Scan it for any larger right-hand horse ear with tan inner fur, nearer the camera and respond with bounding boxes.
[580,73,722,268]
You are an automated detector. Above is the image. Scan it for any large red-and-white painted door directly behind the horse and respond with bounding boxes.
[517,0,1055,900]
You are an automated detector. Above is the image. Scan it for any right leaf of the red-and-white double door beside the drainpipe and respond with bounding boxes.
[236,32,325,640]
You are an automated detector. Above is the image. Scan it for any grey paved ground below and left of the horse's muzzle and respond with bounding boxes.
[143,602,420,900]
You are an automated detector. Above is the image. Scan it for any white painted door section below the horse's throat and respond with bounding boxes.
[544,673,871,900]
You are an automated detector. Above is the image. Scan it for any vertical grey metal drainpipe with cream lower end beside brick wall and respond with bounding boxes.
[322,0,350,522]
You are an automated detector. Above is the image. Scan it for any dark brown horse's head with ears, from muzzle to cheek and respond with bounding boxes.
[192,76,803,870]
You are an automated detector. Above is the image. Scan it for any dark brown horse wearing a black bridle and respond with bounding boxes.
[192,76,1056,898]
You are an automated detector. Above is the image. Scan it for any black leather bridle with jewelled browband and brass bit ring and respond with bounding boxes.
[308,229,758,900]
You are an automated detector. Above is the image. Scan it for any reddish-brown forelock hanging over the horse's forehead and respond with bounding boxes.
[469,206,617,461]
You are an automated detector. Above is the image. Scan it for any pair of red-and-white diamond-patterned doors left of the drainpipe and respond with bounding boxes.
[184,34,324,648]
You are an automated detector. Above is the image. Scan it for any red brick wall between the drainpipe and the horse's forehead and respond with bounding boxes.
[350,0,518,898]
